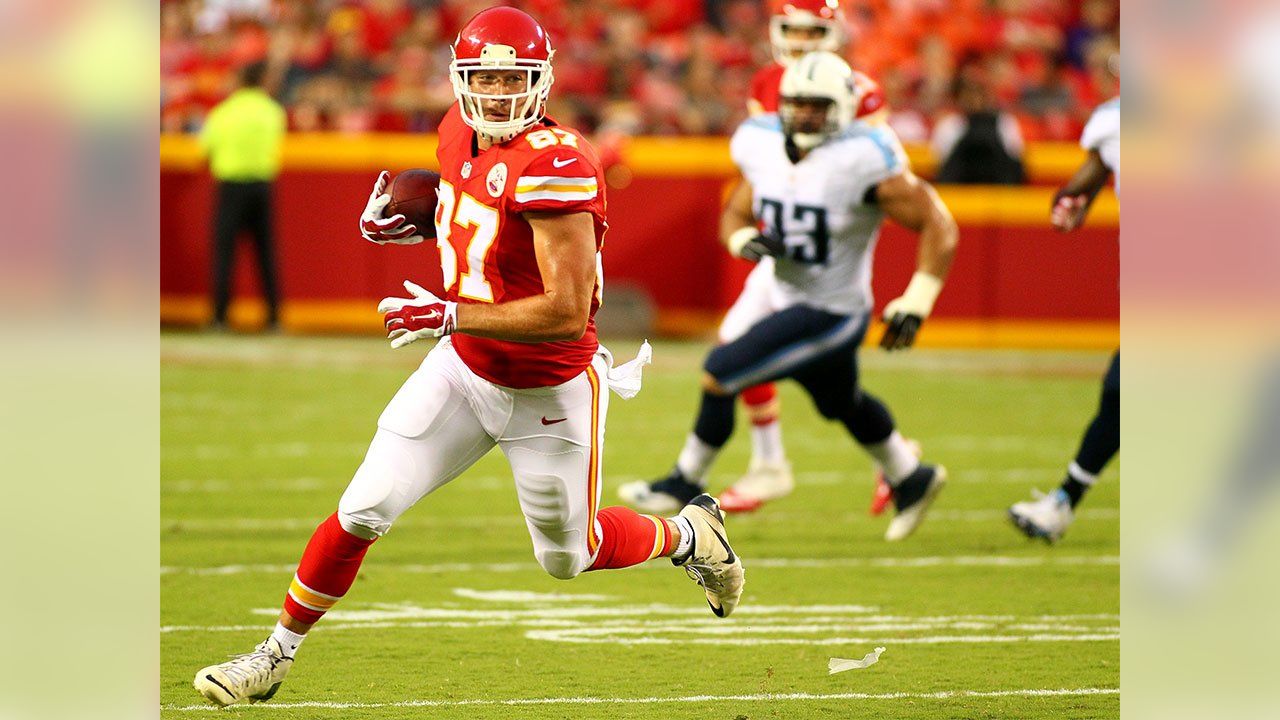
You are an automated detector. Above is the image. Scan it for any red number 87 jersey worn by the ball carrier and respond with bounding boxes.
[435,105,608,388]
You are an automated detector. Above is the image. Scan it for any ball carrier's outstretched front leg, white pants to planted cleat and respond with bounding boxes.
[195,342,494,706]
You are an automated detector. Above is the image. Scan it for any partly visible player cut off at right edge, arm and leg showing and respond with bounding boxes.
[1009,90,1120,542]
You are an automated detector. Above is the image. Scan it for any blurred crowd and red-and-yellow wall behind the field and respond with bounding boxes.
[160,0,1119,348]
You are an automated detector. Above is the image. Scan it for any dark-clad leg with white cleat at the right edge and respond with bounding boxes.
[1009,350,1120,542]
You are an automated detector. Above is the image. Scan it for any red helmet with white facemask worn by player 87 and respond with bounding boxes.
[449,8,556,142]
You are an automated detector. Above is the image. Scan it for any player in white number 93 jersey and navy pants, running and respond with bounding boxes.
[622,51,959,541]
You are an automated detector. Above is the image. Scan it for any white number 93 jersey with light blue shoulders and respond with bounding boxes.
[730,114,908,315]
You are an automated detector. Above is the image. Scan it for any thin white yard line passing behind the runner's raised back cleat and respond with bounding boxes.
[160,555,1120,575]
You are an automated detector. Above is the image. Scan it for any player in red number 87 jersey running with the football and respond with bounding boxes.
[195,8,742,706]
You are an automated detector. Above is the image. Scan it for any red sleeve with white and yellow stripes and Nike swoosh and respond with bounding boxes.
[512,145,603,213]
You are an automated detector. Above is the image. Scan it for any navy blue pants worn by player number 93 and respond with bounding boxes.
[694,305,893,447]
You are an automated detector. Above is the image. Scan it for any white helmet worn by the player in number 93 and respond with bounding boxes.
[778,51,859,150]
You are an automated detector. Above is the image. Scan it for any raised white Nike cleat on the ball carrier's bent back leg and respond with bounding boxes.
[672,493,745,618]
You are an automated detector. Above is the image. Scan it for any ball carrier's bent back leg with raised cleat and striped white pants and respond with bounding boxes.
[493,356,742,618]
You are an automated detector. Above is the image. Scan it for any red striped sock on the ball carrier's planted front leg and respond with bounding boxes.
[284,512,374,623]
